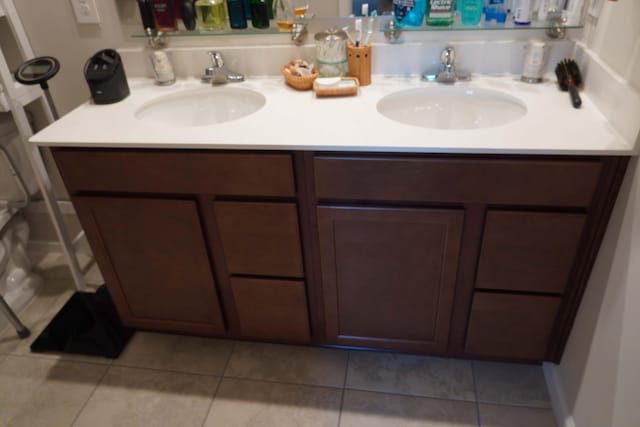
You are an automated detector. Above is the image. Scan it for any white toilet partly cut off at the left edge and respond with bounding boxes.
[0,113,42,330]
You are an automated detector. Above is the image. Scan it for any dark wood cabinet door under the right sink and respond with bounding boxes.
[318,207,463,352]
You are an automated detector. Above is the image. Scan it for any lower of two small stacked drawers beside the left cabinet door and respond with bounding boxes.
[231,278,310,343]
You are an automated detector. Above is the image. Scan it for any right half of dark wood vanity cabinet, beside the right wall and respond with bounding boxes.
[312,153,626,360]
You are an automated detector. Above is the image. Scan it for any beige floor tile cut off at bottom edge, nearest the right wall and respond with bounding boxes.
[478,404,557,427]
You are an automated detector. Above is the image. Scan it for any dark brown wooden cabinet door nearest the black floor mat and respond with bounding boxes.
[73,197,224,335]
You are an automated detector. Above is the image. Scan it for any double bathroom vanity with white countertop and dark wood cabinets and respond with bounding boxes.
[32,79,635,361]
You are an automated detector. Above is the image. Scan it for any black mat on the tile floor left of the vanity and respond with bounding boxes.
[31,285,134,359]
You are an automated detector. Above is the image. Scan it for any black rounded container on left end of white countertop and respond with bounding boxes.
[84,49,129,104]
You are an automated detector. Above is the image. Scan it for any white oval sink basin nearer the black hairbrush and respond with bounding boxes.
[377,86,527,129]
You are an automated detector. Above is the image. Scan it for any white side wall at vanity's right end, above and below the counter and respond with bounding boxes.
[545,0,640,427]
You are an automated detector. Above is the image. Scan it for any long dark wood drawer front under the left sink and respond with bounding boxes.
[53,149,295,197]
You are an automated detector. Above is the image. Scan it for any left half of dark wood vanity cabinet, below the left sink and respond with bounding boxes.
[53,149,310,343]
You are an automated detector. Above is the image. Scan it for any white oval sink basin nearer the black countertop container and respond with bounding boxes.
[135,85,266,127]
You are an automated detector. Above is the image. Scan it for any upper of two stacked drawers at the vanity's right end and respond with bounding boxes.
[476,211,586,293]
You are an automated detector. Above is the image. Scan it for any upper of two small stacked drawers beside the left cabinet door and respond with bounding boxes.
[214,202,304,278]
